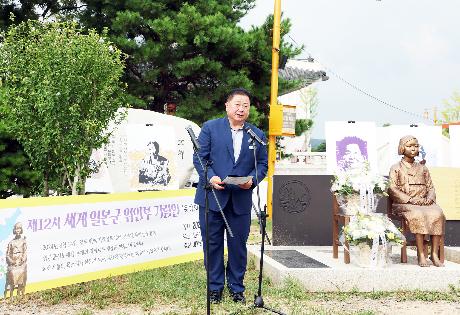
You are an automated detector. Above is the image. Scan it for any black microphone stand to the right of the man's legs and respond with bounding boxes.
[248,133,285,315]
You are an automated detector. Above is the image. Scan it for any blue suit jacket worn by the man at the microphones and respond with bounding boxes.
[193,117,268,214]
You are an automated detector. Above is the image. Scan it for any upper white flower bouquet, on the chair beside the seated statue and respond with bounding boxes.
[331,164,388,215]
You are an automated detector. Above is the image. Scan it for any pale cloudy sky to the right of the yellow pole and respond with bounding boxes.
[241,0,460,138]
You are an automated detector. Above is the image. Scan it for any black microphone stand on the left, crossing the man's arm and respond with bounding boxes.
[189,132,233,315]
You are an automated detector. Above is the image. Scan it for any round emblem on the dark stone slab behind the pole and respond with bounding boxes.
[279,180,311,213]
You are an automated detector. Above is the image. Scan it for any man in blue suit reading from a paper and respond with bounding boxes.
[193,89,268,303]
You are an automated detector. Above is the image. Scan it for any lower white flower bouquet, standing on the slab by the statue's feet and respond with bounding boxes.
[341,214,405,267]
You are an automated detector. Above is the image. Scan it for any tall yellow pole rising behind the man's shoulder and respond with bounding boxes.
[267,0,281,218]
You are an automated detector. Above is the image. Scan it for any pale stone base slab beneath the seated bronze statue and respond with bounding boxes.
[248,245,460,292]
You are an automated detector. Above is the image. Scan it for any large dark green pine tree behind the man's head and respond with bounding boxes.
[73,0,300,127]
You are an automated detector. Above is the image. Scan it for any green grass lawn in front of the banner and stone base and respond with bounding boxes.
[3,222,460,315]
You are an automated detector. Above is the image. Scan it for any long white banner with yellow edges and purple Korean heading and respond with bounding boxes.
[0,189,202,294]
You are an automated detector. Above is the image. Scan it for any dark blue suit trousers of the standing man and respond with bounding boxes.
[200,198,251,292]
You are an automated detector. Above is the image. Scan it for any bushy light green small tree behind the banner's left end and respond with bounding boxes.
[0,21,123,195]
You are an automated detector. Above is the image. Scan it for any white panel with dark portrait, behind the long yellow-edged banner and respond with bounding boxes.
[85,109,200,193]
